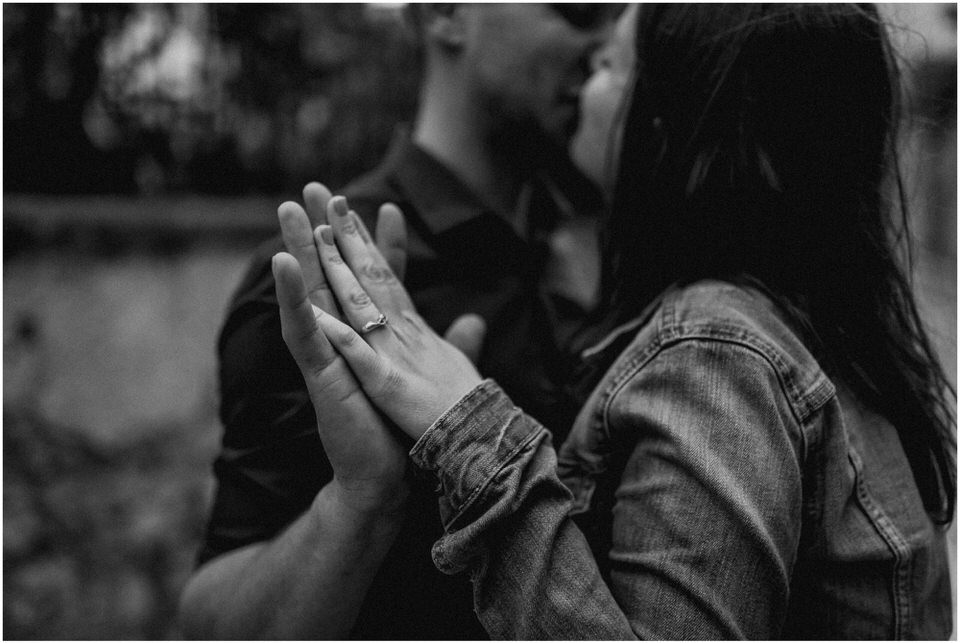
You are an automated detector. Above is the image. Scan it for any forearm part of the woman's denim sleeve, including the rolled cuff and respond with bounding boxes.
[410,380,634,640]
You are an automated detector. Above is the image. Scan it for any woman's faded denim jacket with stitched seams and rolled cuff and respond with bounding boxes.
[411,282,952,639]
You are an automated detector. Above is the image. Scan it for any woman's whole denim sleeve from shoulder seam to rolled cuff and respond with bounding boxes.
[411,341,801,639]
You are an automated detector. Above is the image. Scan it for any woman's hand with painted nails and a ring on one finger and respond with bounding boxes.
[278,196,483,439]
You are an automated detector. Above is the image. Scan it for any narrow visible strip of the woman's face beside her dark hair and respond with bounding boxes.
[570,4,639,193]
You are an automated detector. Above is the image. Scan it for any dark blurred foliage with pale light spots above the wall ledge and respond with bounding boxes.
[3,4,417,194]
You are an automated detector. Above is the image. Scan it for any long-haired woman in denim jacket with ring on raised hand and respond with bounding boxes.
[274,5,956,639]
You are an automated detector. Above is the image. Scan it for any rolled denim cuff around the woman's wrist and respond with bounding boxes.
[410,380,545,527]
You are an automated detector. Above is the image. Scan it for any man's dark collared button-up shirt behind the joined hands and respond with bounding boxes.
[199,132,576,639]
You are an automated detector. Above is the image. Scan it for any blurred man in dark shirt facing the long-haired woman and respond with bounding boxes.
[182,4,614,639]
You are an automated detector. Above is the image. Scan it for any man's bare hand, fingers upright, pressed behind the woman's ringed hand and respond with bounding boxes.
[273,183,407,512]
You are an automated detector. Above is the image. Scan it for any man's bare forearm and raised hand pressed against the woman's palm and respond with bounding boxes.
[174,189,408,640]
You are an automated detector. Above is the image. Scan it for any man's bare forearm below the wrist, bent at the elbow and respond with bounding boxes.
[181,481,402,639]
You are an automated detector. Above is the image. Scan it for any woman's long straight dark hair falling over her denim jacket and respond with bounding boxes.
[601,4,956,523]
